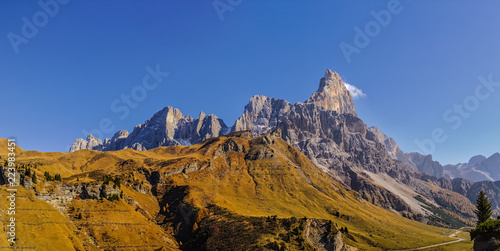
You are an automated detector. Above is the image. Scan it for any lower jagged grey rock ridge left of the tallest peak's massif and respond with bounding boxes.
[70,106,229,152]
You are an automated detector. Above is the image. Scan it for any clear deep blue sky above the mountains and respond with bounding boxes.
[0,0,500,163]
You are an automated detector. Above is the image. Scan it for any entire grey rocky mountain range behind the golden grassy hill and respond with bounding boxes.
[70,70,500,226]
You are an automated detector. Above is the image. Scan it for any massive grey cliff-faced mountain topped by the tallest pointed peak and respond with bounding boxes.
[232,70,428,216]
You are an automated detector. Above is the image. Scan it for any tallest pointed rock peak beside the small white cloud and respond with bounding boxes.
[305,69,356,115]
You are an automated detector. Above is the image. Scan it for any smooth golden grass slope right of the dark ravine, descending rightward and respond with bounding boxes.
[156,134,453,250]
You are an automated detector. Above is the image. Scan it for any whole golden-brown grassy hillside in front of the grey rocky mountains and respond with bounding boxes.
[0,132,460,250]
